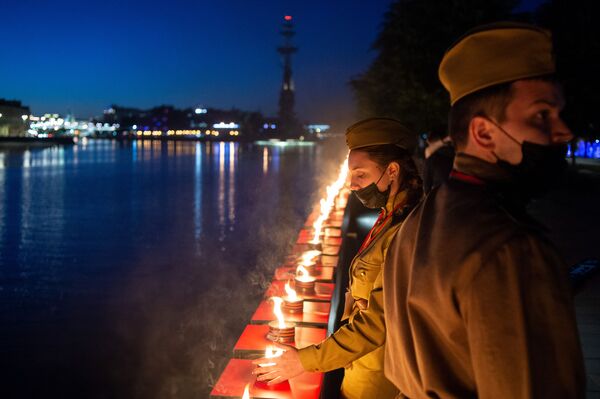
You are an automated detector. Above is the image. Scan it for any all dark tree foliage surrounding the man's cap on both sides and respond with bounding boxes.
[350,0,600,141]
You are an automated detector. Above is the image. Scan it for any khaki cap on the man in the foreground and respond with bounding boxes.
[438,22,556,105]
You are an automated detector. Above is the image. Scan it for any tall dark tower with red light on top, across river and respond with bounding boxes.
[277,15,300,137]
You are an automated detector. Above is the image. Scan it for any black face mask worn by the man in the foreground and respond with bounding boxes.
[492,122,567,198]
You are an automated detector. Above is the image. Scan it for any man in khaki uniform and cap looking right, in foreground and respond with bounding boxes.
[383,23,585,399]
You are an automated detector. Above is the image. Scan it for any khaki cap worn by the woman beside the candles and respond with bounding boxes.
[346,118,417,153]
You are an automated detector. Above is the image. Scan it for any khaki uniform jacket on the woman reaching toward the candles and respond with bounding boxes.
[298,192,406,371]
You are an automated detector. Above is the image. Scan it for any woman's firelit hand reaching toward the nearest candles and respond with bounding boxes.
[252,343,305,385]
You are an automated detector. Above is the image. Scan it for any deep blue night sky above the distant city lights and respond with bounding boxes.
[0,0,542,128]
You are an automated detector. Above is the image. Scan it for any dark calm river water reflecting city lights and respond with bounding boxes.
[0,140,344,398]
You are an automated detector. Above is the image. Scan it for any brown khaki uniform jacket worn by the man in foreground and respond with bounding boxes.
[383,154,585,399]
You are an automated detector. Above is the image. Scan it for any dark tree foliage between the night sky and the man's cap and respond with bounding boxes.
[350,0,523,132]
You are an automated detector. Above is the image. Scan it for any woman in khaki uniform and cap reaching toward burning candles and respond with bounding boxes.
[254,118,422,399]
